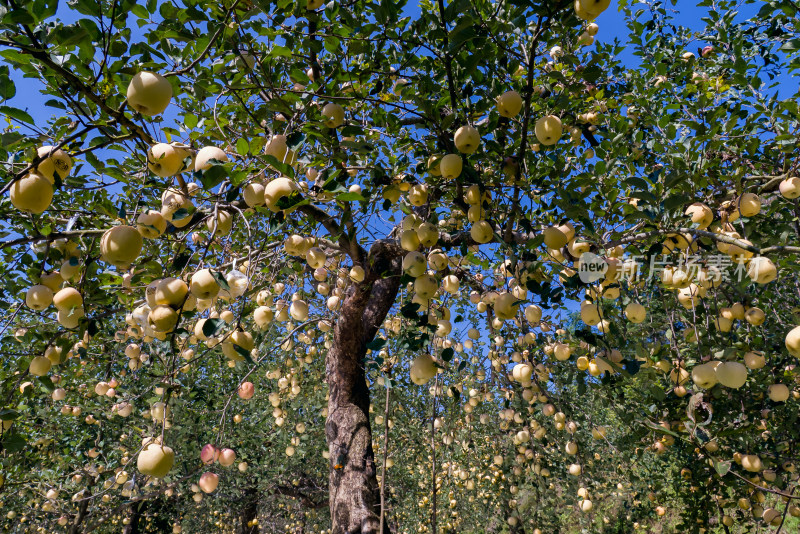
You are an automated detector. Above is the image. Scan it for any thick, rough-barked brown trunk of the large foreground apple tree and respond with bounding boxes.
[325,241,402,534]
